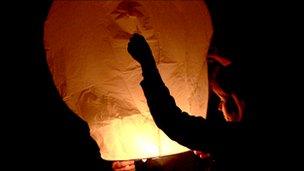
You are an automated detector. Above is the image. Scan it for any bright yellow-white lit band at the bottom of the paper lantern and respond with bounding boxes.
[90,114,189,160]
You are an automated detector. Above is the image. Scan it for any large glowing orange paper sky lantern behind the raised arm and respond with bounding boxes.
[45,0,212,160]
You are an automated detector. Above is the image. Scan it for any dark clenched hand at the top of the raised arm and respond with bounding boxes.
[128,33,155,67]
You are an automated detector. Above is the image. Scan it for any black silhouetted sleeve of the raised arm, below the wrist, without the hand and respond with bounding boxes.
[140,67,220,151]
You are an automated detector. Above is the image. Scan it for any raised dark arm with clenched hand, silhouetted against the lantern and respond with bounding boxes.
[128,34,241,151]
